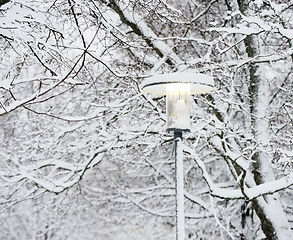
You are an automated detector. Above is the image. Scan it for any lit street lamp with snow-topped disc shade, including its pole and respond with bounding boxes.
[141,73,214,240]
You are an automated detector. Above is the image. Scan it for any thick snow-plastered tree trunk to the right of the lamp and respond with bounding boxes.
[221,0,292,240]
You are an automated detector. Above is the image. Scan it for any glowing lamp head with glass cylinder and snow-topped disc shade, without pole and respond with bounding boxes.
[141,72,214,132]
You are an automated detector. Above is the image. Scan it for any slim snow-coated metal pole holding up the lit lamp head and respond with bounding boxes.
[174,131,185,240]
